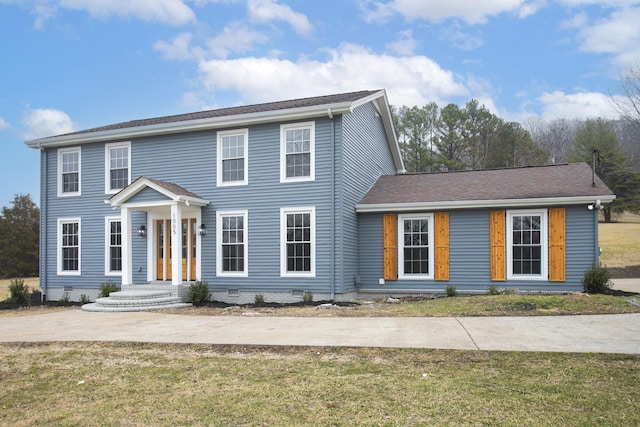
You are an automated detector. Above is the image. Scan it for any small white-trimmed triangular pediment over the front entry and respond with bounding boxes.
[107,176,209,208]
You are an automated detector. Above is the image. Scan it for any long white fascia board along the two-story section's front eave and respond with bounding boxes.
[25,102,352,149]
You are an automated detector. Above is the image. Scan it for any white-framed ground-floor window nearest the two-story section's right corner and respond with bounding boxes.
[280,207,316,277]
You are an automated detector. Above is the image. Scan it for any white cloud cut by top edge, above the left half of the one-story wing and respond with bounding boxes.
[365,0,540,24]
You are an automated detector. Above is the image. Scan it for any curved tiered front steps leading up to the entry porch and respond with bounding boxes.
[82,290,191,312]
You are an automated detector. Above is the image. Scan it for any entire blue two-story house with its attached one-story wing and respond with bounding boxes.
[27,91,615,303]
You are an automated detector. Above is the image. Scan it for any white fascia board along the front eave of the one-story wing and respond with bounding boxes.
[356,195,616,213]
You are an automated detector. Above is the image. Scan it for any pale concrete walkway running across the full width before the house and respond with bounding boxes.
[0,309,640,354]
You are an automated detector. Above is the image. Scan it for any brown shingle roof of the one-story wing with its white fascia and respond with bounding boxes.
[356,163,615,212]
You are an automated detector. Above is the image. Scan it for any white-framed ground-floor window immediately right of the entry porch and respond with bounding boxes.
[216,211,248,277]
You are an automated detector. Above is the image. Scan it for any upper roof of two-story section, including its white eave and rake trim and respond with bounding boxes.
[25,90,404,172]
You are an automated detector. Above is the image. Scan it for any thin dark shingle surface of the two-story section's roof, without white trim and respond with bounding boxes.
[57,90,379,136]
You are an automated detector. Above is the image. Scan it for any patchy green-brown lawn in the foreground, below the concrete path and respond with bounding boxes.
[0,343,640,426]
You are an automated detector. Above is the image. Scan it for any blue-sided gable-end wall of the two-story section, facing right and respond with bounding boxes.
[335,103,396,292]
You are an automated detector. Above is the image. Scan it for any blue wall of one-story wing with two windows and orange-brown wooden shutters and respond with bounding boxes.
[359,204,597,293]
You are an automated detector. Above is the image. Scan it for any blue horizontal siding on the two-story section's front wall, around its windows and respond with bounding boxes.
[43,116,340,293]
